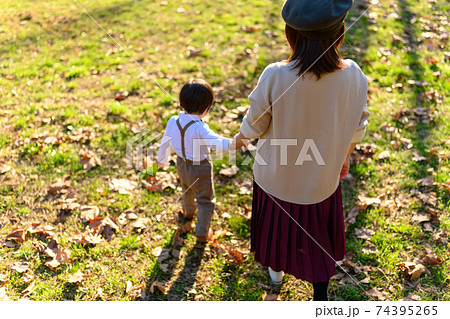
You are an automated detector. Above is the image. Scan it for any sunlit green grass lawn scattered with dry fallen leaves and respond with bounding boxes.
[0,0,450,300]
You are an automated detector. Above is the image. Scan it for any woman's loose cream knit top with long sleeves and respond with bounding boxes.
[241,60,369,204]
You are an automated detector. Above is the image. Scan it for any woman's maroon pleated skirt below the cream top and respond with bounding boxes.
[251,182,345,283]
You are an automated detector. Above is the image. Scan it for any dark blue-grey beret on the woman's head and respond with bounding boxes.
[281,0,353,40]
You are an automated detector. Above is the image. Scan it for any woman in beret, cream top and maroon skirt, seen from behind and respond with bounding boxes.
[234,0,369,300]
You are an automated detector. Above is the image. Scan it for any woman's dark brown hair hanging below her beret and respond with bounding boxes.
[285,24,345,80]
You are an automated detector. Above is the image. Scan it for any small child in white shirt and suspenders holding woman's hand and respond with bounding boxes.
[158,80,234,242]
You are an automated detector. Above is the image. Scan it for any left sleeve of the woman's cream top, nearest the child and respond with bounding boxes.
[241,66,273,139]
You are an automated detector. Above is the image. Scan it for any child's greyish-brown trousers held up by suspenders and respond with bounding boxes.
[177,156,215,236]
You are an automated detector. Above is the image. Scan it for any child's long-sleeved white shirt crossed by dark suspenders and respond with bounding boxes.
[158,113,230,164]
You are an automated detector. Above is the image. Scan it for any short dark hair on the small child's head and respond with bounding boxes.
[180,79,214,114]
